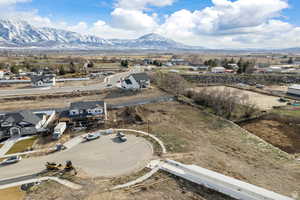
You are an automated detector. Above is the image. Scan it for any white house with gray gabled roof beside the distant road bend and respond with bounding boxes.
[121,73,150,90]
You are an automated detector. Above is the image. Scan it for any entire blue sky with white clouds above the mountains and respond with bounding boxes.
[0,0,300,48]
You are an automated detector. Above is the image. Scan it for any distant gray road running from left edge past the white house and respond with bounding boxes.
[0,69,136,97]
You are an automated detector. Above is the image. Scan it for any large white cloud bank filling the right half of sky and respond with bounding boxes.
[152,0,300,48]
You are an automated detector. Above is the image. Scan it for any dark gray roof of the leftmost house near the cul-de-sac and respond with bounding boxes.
[2,111,41,124]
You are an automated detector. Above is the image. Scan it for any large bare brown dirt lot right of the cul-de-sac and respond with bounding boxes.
[106,102,300,199]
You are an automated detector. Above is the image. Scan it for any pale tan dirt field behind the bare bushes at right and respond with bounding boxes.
[199,86,286,110]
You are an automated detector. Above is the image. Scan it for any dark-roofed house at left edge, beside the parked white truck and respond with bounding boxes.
[0,111,47,139]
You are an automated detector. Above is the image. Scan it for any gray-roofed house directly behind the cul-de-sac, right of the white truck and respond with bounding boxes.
[69,101,107,120]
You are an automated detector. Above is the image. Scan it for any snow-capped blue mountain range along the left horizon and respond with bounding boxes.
[0,20,204,50]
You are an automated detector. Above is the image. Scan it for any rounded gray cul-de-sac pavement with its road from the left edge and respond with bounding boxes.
[0,135,153,182]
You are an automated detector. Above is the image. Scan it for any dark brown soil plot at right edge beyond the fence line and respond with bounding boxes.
[242,120,300,154]
